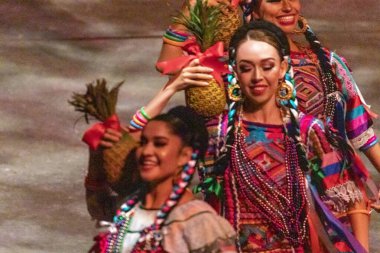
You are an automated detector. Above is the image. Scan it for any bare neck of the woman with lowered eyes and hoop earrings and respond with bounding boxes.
[243,100,283,125]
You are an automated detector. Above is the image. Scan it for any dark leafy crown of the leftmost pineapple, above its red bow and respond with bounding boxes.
[68,78,124,123]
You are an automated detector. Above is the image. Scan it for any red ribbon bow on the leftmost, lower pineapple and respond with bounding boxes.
[82,114,120,150]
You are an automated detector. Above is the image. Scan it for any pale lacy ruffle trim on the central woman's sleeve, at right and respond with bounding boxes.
[324,181,363,213]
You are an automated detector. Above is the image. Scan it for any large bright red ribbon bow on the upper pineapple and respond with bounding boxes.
[157,38,228,84]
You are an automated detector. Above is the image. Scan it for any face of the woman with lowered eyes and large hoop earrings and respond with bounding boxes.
[235,40,287,107]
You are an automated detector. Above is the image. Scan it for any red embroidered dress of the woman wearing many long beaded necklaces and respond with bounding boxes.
[200,111,362,252]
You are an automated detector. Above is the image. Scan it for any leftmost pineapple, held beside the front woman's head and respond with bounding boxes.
[68,79,137,186]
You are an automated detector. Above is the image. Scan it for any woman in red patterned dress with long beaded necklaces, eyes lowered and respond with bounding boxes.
[191,21,366,252]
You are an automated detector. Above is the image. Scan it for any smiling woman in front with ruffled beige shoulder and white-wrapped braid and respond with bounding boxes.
[90,107,236,253]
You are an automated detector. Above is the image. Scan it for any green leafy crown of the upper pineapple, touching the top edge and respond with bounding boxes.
[172,0,222,51]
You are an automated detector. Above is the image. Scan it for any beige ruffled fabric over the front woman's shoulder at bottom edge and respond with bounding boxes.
[164,200,235,253]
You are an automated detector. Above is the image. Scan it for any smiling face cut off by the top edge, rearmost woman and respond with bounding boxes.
[253,0,301,34]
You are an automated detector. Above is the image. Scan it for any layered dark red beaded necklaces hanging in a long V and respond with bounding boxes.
[231,108,308,247]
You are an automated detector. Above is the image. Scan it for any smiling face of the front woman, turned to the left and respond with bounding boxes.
[136,120,192,184]
